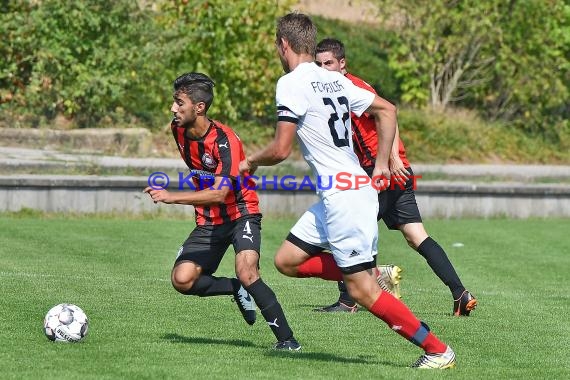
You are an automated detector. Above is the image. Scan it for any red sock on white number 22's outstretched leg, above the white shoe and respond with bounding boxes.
[370,292,447,354]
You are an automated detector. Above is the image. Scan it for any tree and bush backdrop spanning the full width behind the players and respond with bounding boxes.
[0,0,570,157]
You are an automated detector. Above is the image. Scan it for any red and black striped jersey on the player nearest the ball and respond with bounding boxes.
[170,120,259,225]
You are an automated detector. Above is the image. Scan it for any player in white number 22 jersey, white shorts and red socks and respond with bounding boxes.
[240,13,455,368]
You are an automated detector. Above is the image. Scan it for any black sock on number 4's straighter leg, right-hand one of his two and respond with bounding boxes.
[245,278,293,342]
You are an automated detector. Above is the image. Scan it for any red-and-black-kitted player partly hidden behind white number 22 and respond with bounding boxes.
[315,38,477,316]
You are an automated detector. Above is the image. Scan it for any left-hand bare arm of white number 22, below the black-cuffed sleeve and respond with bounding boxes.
[239,120,297,174]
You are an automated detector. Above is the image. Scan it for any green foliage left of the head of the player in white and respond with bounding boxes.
[0,0,288,127]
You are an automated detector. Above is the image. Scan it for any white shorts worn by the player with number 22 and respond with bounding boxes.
[291,186,378,268]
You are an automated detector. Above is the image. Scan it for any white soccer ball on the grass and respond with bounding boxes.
[44,303,89,342]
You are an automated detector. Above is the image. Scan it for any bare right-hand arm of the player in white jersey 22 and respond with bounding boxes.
[366,95,397,184]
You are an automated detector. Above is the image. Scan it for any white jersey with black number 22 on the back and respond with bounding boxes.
[276,62,375,197]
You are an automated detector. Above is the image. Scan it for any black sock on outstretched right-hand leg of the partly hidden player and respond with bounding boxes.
[418,236,465,299]
